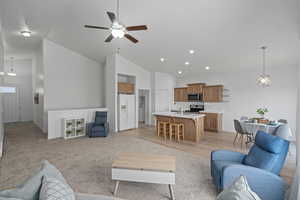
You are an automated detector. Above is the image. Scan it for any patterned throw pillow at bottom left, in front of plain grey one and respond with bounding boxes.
[40,176,75,200]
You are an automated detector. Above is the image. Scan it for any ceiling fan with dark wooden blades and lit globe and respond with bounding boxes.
[84,0,148,43]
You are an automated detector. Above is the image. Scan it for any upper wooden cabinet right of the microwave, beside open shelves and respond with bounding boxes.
[203,85,224,102]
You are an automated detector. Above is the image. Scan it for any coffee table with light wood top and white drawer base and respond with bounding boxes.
[112,153,176,200]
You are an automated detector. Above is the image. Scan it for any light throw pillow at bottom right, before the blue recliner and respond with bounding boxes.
[217,176,261,200]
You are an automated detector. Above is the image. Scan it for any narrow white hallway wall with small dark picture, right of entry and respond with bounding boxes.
[32,42,47,132]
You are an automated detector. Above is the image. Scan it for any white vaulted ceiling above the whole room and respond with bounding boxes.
[0,0,300,76]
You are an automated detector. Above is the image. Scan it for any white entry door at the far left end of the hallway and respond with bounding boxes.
[3,88,21,123]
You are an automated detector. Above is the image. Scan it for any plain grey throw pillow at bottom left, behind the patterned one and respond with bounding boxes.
[0,161,66,200]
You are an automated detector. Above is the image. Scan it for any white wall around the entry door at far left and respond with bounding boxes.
[4,59,33,121]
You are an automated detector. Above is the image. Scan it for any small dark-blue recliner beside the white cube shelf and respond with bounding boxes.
[87,111,109,137]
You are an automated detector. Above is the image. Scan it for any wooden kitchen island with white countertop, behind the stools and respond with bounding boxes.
[153,112,205,143]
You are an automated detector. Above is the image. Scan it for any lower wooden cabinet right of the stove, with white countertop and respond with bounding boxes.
[201,112,223,132]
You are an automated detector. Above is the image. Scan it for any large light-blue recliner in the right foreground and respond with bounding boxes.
[211,131,289,200]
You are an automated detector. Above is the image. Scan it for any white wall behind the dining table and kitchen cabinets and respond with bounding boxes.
[177,66,297,133]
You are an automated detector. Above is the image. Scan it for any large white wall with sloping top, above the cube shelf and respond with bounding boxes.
[43,39,104,130]
